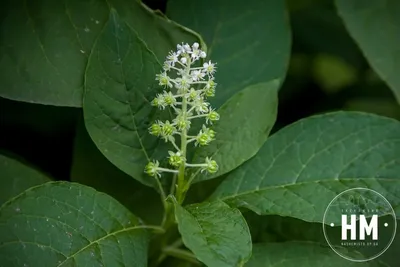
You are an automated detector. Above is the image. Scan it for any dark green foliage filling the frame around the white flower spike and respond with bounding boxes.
[0,0,400,267]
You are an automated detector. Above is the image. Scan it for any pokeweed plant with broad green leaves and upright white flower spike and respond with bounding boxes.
[0,0,400,267]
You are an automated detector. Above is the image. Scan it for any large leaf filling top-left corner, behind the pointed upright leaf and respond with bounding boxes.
[0,0,199,107]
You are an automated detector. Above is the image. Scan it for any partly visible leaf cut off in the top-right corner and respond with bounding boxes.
[335,0,400,102]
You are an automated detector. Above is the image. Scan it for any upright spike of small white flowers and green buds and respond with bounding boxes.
[145,43,219,177]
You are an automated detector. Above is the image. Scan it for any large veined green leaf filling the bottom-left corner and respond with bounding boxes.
[0,182,148,267]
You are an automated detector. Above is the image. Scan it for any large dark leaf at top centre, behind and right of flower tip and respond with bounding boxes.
[167,0,291,107]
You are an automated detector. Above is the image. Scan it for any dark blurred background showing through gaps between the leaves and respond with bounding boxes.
[0,0,400,266]
